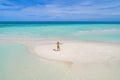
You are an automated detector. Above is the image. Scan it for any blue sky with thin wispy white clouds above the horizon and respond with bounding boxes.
[0,0,120,21]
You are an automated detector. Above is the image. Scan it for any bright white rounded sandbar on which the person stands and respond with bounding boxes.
[34,41,120,63]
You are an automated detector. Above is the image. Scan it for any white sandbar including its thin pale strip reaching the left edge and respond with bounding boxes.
[0,38,120,63]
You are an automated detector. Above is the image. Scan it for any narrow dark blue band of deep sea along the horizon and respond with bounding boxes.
[0,21,120,24]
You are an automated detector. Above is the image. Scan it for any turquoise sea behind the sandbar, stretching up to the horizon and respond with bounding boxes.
[0,22,120,41]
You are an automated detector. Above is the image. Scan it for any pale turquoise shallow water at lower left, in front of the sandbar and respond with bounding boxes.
[0,43,71,80]
